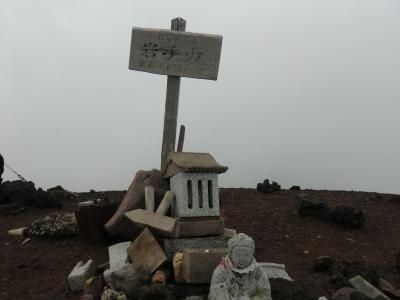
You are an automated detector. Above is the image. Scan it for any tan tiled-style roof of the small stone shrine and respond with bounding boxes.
[162,152,228,178]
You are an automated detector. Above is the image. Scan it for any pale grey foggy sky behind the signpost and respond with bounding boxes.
[0,0,400,193]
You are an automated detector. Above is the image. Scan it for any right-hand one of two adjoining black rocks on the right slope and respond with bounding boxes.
[330,205,365,228]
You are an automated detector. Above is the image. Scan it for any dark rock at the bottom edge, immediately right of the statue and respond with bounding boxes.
[269,278,314,300]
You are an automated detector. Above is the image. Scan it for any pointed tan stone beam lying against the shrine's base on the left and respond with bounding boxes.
[125,209,178,237]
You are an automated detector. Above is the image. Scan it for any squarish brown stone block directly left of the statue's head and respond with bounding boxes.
[183,249,228,283]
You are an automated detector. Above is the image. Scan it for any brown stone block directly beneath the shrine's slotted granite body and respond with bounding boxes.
[178,217,224,237]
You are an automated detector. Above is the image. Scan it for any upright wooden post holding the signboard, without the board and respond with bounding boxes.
[161,18,186,170]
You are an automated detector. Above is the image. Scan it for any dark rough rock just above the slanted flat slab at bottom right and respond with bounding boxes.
[330,261,379,288]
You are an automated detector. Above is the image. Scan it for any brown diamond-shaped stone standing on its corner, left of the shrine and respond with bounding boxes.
[127,228,167,279]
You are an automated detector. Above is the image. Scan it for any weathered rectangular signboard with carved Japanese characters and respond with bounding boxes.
[129,27,222,80]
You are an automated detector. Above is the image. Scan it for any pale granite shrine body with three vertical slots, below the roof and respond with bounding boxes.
[170,173,219,218]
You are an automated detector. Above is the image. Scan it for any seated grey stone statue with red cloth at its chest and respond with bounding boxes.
[208,233,272,300]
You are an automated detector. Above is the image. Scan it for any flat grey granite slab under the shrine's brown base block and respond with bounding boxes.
[161,236,228,260]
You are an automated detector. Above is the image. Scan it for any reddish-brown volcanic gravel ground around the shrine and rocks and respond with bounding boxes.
[0,189,400,299]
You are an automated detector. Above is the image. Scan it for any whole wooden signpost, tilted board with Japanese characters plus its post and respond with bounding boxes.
[129,18,222,170]
